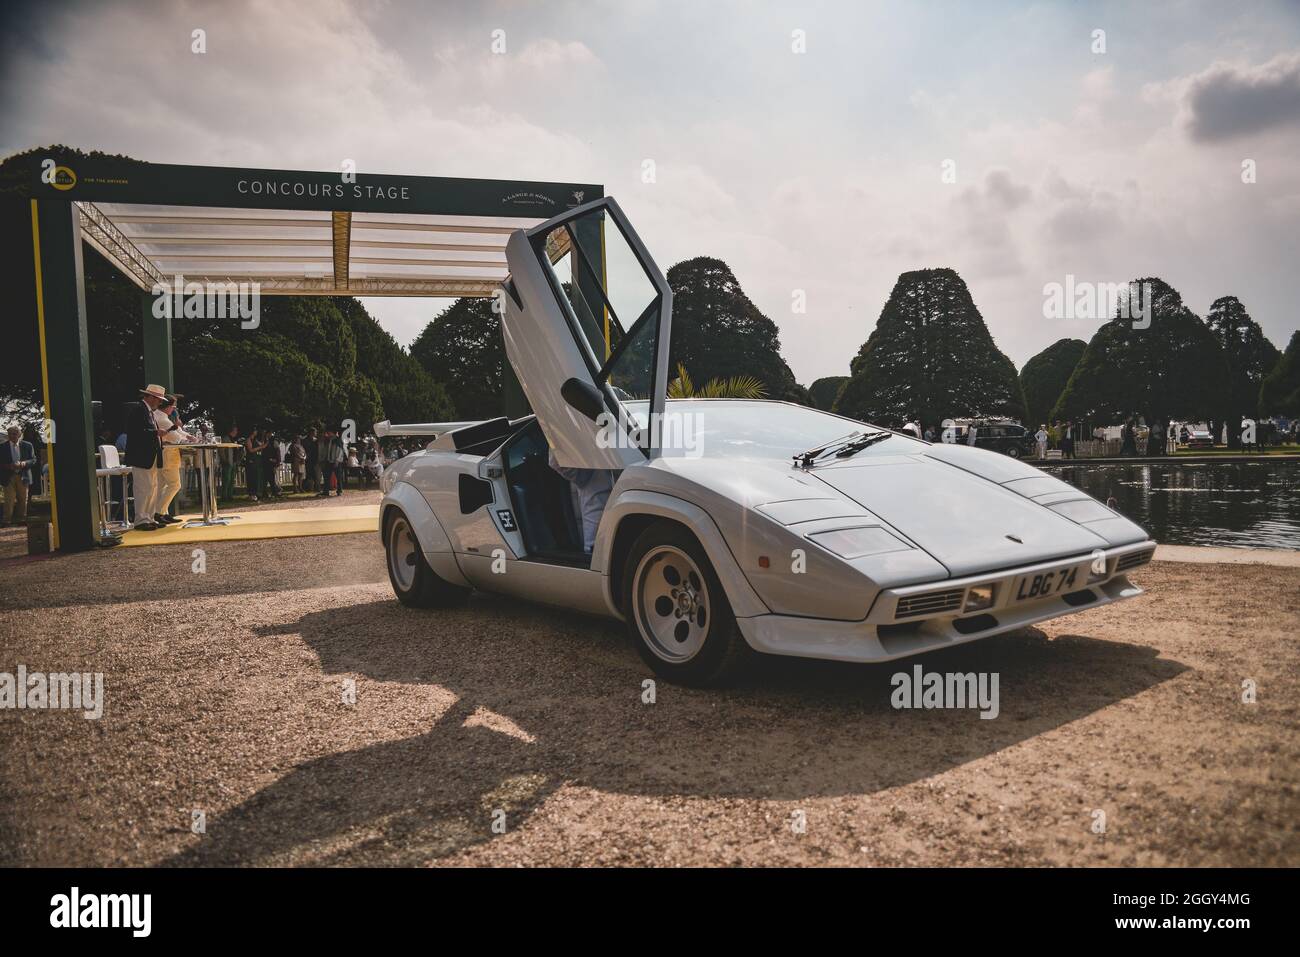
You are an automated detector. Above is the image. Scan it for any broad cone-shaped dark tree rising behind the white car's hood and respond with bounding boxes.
[835,269,1024,428]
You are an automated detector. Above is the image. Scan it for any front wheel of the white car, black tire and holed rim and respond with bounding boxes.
[621,521,753,687]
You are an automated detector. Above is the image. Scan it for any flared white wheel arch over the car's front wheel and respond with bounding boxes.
[592,489,770,618]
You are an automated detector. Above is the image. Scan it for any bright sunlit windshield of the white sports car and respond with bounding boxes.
[624,399,923,459]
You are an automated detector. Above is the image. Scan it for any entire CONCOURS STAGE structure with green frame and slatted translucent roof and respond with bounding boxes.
[23,150,605,550]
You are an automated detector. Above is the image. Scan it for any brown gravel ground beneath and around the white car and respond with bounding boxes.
[0,514,1300,866]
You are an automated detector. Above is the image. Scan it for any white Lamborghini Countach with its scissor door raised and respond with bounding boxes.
[378,198,1156,684]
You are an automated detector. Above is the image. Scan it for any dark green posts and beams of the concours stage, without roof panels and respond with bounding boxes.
[20,150,605,551]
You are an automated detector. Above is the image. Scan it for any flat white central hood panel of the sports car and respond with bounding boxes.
[807,450,1110,577]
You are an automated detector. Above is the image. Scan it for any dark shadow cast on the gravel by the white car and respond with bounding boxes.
[165,596,1186,865]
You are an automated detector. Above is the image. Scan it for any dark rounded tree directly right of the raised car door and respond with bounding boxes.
[668,256,809,404]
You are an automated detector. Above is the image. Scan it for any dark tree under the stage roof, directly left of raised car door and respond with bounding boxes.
[411,298,506,420]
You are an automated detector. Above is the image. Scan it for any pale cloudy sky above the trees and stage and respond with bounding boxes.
[0,0,1300,384]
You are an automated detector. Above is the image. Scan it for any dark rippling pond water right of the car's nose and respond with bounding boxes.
[1048,459,1300,549]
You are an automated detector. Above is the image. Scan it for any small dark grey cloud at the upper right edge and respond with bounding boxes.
[1183,53,1300,143]
